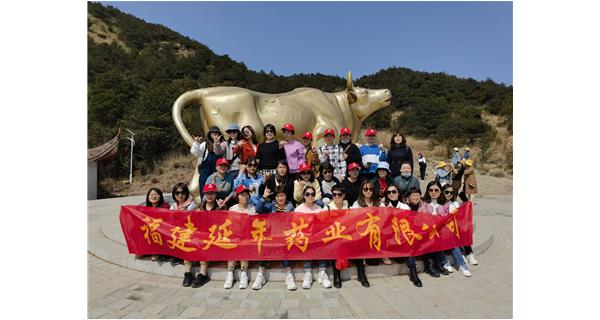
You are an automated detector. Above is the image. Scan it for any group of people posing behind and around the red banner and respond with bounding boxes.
[138,123,477,290]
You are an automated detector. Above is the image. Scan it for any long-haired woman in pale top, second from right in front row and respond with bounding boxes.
[422,181,450,278]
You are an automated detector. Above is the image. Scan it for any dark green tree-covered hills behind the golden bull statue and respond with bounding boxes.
[88,2,512,190]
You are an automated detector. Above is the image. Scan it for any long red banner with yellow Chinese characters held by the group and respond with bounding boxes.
[120,202,473,261]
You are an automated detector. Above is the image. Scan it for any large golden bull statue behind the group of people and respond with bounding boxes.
[173,72,392,200]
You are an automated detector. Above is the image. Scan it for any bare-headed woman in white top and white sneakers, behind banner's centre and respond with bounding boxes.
[292,185,331,289]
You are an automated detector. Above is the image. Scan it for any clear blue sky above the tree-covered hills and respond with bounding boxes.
[102,2,513,84]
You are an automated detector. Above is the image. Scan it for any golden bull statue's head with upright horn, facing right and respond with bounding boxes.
[345,71,392,122]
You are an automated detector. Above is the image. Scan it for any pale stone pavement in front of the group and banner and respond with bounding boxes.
[88,196,513,318]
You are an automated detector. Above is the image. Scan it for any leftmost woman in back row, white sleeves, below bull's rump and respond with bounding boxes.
[190,126,227,195]
